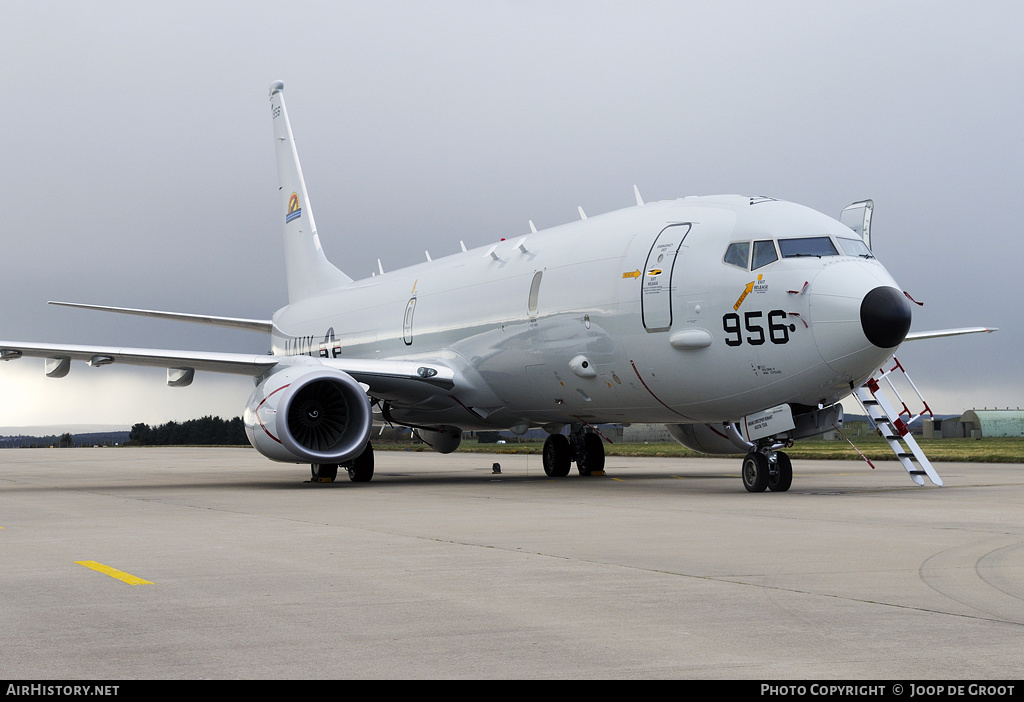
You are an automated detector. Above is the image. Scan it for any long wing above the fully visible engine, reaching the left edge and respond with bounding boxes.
[0,341,455,401]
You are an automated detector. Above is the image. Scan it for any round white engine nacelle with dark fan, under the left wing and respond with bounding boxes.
[244,364,373,464]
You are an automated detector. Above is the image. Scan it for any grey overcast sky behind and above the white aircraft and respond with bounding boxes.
[0,0,1024,428]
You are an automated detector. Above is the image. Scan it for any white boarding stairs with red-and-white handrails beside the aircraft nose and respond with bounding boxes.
[854,356,942,486]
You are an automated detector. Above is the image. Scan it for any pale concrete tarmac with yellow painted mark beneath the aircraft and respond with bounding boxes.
[0,448,1024,681]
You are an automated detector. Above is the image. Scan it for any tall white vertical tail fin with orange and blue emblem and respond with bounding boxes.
[270,81,352,303]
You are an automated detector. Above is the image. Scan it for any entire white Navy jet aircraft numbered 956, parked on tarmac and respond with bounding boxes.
[0,82,986,491]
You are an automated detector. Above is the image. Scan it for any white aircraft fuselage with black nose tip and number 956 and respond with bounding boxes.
[273,195,909,429]
